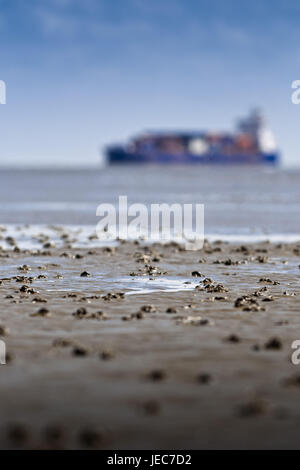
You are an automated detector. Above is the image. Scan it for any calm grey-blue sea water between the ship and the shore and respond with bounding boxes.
[0,166,300,239]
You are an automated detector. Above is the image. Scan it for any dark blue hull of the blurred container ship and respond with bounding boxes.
[107,147,279,165]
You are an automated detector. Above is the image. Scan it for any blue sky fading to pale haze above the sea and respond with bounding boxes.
[0,0,300,167]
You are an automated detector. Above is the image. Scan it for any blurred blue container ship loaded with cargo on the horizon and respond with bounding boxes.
[106,110,279,165]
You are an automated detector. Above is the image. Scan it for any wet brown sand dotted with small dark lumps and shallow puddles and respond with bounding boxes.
[0,230,300,449]
